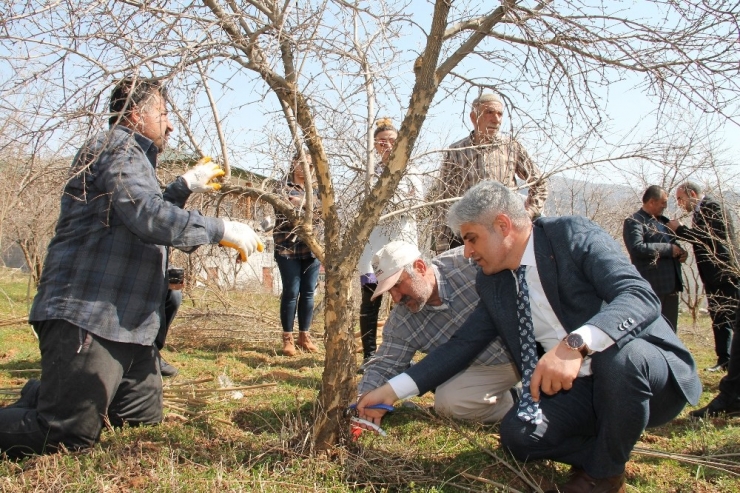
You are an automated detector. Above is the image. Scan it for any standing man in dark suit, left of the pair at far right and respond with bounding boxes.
[622,185,688,332]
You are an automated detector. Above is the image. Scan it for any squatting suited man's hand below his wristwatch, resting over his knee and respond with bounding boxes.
[529,342,583,402]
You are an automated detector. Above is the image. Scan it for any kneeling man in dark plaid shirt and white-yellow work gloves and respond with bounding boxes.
[0,77,261,457]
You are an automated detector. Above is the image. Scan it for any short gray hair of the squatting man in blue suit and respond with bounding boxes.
[447,181,531,234]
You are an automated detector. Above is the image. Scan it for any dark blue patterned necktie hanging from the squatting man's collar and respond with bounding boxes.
[516,265,542,425]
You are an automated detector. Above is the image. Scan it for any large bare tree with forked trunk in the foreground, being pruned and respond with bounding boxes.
[0,0,740,450]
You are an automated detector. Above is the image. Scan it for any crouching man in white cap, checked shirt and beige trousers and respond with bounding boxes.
[358,241,519,423]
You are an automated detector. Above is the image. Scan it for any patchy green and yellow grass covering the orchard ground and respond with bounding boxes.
[0,271,740,493]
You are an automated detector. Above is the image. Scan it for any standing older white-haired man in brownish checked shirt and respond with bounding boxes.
[428,93,547,253]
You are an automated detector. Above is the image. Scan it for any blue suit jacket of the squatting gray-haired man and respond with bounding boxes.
[407,217,701,404]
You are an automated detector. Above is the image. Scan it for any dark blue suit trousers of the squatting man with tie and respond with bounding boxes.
[500,339,686,478]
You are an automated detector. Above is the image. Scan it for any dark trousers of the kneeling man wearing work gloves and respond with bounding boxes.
[0,320,162,457]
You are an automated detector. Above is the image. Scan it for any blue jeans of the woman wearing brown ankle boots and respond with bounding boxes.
[275,255,321,332]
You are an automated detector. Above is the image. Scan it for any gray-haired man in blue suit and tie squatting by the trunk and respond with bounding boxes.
[358,182,701,493]
